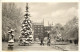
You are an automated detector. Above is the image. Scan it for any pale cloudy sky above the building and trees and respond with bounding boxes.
[16,2,78,26]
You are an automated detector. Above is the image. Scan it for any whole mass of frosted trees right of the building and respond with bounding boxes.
[51,17,78,40]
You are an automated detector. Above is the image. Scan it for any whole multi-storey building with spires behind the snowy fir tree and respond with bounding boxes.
[32,20,51,40]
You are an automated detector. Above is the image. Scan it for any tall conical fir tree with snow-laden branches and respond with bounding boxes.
[20,3,32,45]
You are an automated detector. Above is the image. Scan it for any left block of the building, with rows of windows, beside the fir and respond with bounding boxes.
[33,23,44,40]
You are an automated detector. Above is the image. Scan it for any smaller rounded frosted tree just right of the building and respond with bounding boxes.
[51,23,64,39]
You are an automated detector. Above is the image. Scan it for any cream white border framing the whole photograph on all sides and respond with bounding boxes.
[0,0,80,52]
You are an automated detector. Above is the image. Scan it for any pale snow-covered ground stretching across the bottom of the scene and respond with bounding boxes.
[2,42,78,51]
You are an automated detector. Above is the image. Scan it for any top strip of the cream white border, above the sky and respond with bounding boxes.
[1,0,79,2]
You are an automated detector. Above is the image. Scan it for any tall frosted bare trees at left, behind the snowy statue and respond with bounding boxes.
[2,3,22,41]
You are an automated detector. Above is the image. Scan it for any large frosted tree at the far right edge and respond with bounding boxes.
[63,17,78,40]
